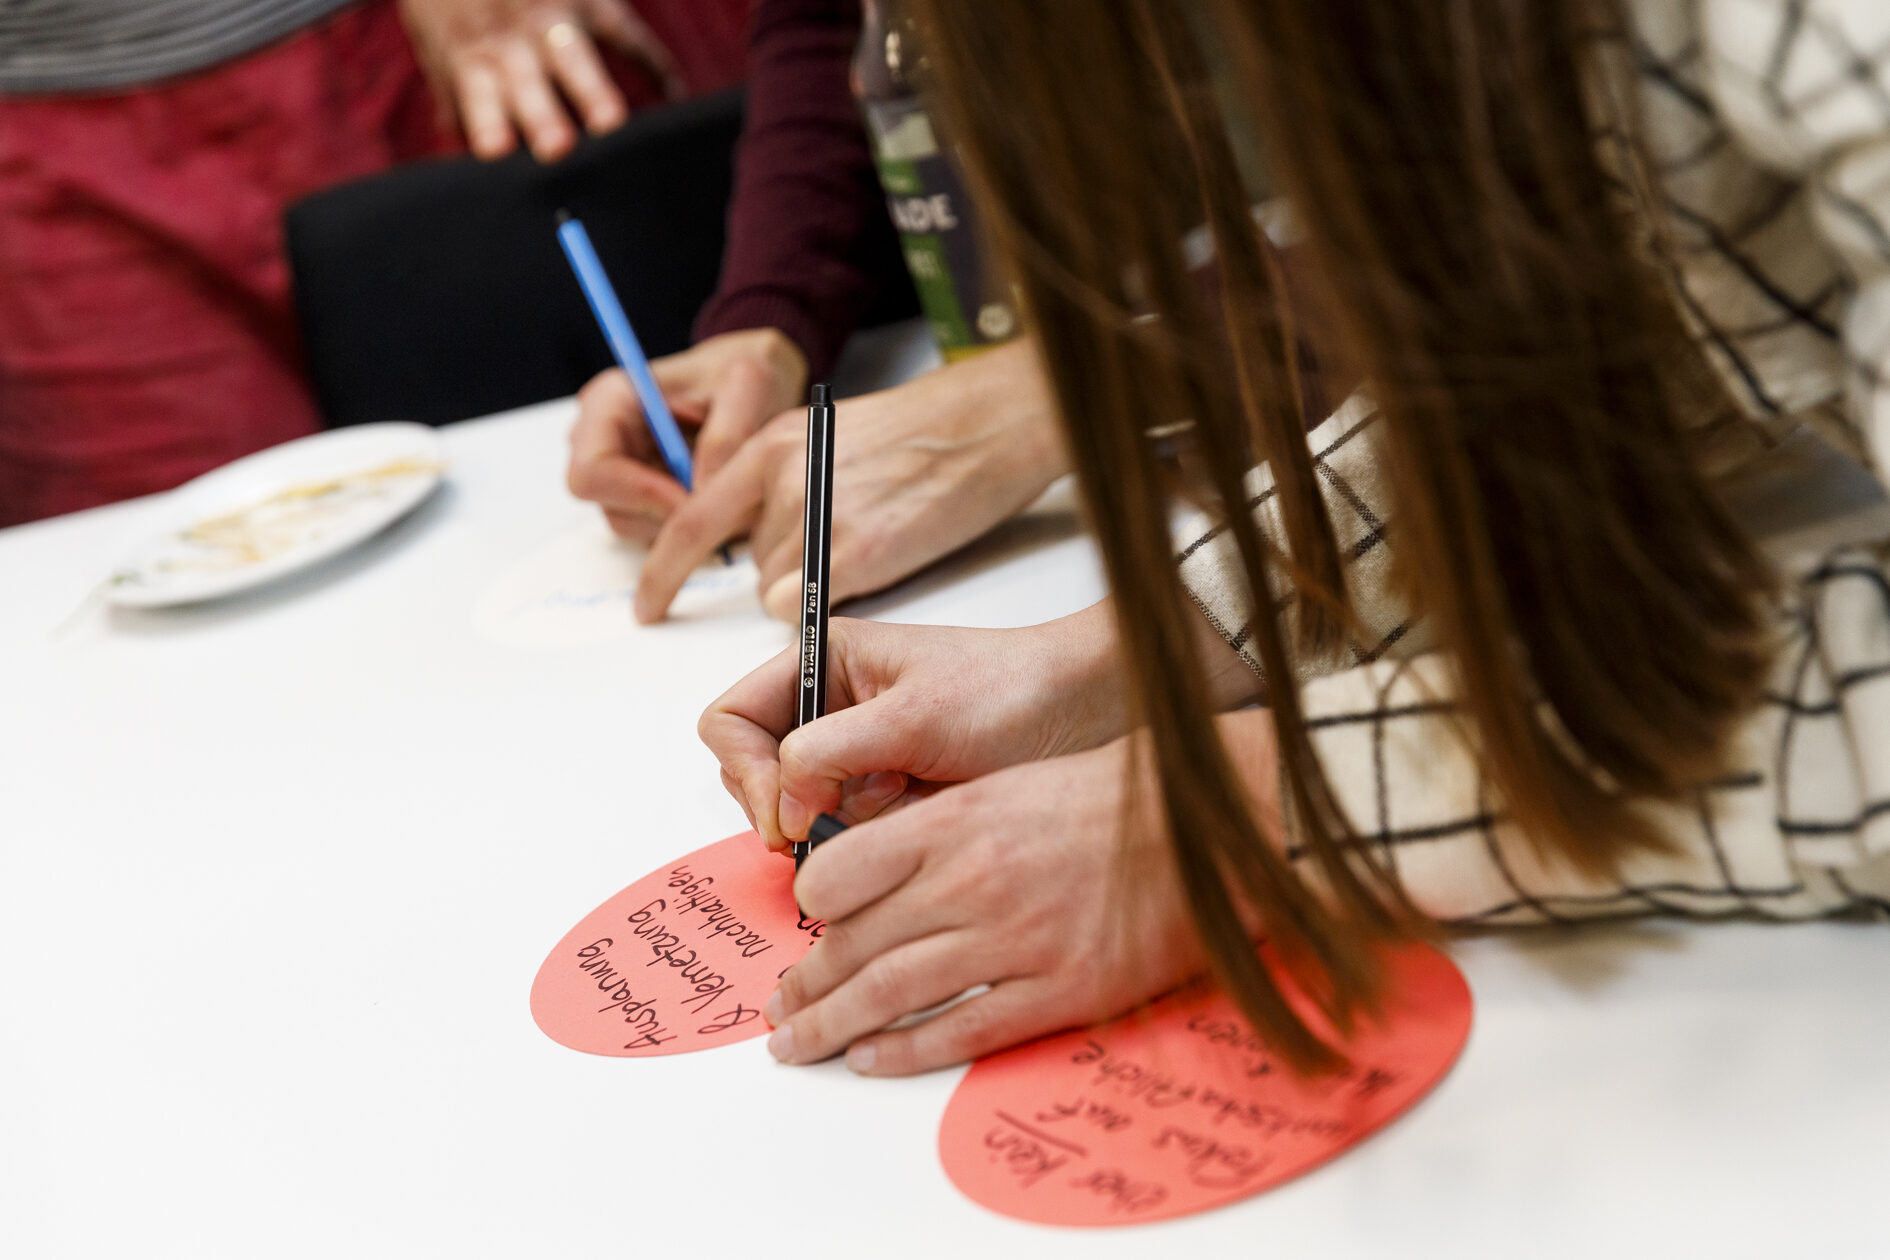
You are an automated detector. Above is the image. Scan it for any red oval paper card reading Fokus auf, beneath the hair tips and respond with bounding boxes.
[939,945,1470,1226]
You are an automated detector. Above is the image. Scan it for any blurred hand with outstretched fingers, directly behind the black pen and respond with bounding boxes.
[637,342,1066,621]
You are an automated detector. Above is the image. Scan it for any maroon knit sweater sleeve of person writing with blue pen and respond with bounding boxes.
[696,0,890,380]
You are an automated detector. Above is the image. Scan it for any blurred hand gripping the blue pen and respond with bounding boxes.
[565,329,807,546]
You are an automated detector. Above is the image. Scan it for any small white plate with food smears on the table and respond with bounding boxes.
[106,423,446,608]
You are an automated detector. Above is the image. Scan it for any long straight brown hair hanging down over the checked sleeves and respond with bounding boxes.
[907,0,1769,1067]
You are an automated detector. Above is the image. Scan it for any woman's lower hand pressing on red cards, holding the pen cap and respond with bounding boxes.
[762,739,1204,1077]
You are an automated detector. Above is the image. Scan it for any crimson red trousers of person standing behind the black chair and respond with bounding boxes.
[0,0,747,525]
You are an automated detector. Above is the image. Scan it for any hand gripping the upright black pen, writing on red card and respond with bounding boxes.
[697,603,1126,850]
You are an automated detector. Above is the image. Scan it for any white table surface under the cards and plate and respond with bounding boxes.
[0,328,1890,1260]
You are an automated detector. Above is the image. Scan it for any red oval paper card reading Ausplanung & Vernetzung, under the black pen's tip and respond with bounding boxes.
[531,831,824,1058]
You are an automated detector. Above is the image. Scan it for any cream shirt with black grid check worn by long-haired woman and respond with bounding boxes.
[1179,0,1890,924]
